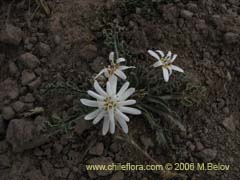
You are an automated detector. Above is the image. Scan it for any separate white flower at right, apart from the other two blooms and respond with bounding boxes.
[148,50,184,82]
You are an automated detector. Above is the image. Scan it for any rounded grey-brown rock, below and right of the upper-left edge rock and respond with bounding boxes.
[19,52,40,69]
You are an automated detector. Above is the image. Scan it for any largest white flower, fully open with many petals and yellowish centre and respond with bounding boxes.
[80,77,141,135]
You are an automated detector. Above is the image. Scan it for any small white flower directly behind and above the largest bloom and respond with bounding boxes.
[95,52,135,80]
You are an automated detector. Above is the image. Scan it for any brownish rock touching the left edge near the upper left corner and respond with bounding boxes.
[0,24,23,46]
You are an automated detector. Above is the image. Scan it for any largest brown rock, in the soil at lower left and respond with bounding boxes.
[6,119,48,152]
